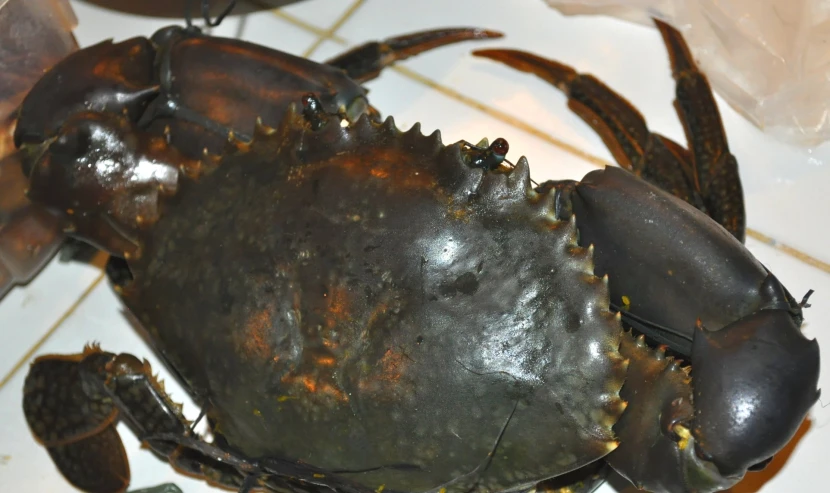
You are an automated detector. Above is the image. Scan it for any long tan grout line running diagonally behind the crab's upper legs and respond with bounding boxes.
[272,6,830,274]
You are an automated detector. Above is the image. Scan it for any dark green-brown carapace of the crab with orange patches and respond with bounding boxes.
[124,112,624,491]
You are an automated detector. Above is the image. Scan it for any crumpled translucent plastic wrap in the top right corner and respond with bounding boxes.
[546,0,830,146]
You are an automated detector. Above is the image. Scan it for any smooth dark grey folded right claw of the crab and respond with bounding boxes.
[576,168,819,491]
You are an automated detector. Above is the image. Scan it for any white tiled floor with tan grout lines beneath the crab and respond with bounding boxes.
[0,0,830,493]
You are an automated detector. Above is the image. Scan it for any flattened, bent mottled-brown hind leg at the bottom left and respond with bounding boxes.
[23,346,260,493]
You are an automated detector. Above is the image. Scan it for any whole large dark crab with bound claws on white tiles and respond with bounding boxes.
[9,6,818,492]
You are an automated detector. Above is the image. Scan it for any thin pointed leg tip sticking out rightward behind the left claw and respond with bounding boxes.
[325,27,503,82]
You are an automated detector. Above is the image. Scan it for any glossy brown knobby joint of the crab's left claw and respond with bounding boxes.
[22,112,199,257]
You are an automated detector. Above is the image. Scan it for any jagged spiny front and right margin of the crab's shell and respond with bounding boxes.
[208,104,629,440]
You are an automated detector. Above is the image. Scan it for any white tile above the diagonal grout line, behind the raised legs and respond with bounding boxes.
[337,0,830,261]
